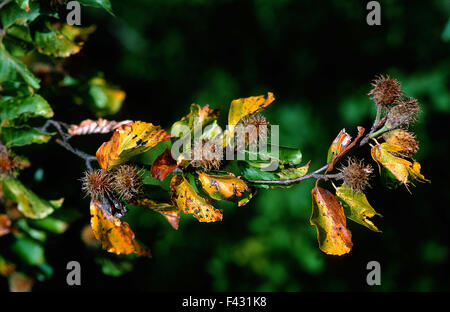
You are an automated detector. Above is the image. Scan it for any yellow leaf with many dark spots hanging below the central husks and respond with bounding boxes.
[170,175,223,222]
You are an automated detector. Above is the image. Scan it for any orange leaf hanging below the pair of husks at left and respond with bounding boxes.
[90,200,151,257]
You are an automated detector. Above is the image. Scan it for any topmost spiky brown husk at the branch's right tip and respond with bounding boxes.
[368,76,403,109]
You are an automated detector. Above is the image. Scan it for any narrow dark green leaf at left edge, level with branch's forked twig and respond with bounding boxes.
[0,126,51,147]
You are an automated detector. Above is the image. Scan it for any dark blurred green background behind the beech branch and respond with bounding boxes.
[2,0,450,291]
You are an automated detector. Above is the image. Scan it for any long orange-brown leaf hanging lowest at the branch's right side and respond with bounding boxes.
[310,186,353,256]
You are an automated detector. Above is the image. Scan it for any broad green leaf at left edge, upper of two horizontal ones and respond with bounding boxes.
[0,94,53,124]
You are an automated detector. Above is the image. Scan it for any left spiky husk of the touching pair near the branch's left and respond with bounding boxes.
[81,169,113,200]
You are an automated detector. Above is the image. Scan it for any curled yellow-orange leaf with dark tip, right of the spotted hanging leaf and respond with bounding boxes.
[197,171,252,206]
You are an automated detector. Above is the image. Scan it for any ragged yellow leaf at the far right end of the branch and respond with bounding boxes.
[371,143,430,185]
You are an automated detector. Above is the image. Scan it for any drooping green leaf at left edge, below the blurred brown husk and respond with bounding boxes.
[2,176,63,219]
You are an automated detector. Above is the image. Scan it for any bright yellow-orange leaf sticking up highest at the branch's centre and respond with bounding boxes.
[226,92,275,144]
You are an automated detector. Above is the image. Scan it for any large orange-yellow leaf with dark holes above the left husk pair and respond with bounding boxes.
[96,121,170,170]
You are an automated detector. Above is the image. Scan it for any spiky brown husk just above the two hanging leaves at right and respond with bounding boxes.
[339,158,373,192]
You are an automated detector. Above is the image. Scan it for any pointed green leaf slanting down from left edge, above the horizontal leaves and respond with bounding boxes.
[0,42,40,89]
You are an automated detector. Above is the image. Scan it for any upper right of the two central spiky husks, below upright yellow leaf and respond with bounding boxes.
[236,114,270,150]
